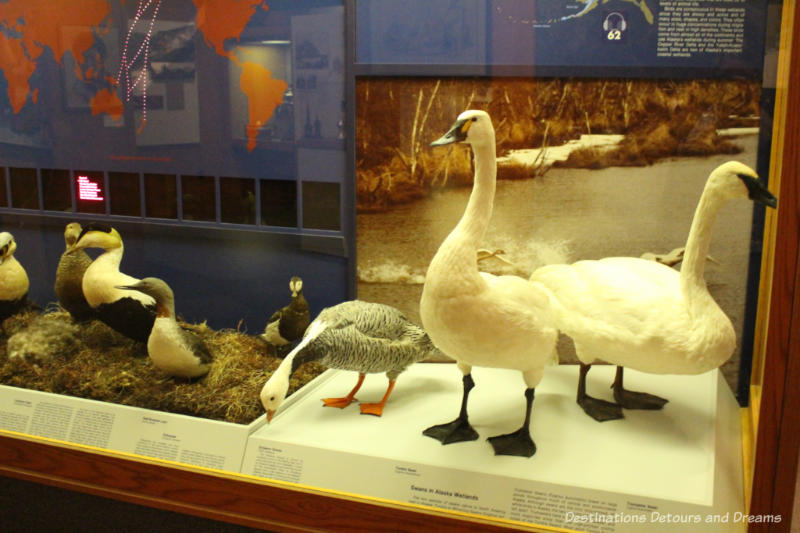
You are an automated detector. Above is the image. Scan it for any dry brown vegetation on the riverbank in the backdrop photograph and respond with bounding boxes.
[356,78,761,212]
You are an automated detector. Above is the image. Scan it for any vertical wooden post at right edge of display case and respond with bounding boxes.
[745,2,800,532]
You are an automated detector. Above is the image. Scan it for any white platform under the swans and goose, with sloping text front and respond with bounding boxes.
[242,364,746,533]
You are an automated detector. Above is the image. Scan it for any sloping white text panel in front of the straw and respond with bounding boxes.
[0,385,266,472]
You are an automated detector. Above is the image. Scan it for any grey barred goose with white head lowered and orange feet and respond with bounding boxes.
[261,300,439,421]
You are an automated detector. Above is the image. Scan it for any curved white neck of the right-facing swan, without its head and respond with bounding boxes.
[680,188,725,314]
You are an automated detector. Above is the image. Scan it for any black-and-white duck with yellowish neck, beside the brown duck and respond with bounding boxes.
[67,224,156,342]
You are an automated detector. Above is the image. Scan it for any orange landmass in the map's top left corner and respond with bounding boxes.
[0,0,111,113]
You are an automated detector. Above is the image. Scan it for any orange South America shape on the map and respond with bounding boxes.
[239,61,289,152]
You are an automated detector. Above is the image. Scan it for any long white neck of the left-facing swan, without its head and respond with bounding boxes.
[431,142,497,276]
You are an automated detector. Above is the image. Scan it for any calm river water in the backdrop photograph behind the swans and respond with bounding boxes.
[358,134,761,387]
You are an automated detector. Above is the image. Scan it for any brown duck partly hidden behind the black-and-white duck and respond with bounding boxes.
[54,222,94,321]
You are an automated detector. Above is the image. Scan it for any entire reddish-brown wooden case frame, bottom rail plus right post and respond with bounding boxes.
[0,2,800,532]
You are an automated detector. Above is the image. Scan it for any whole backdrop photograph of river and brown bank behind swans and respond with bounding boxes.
[356,78,762,390]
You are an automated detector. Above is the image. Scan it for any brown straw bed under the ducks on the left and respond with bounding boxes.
[0,310,324,424]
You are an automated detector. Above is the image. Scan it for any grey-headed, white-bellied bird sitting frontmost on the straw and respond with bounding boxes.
[117,278,212,379]
